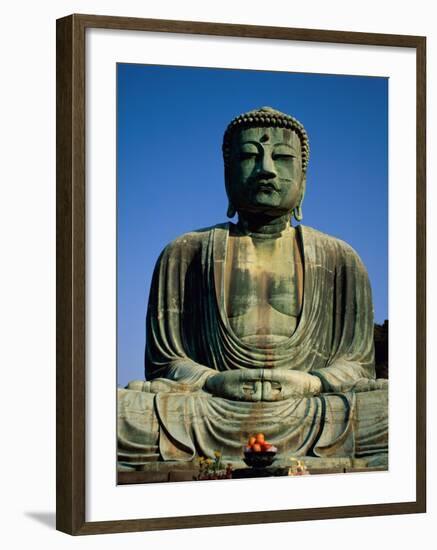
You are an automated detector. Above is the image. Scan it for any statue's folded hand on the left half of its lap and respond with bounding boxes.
[204,369,264,401]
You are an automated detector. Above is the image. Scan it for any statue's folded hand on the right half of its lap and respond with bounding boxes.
[262,369,322,401]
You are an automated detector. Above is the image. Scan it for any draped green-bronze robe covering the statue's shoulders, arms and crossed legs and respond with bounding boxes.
[118,223,388,463]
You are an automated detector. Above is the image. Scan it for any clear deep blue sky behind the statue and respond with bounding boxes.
[117,64,388,385]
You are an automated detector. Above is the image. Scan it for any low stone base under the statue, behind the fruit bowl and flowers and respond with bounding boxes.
[117,457,388,485]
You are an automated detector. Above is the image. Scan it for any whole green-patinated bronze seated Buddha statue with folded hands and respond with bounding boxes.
[118,107,388,465]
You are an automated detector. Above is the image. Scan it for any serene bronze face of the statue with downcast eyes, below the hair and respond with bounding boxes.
[226,128,305,216]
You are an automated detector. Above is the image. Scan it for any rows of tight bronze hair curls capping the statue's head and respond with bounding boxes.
[222,107,310,172]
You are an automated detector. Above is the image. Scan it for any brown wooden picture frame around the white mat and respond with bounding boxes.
[56,15,426,535]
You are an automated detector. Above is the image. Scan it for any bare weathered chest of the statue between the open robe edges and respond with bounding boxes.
[224,231,302,342]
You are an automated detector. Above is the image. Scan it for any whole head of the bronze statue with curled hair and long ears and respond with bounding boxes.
[223,107,309,220]
